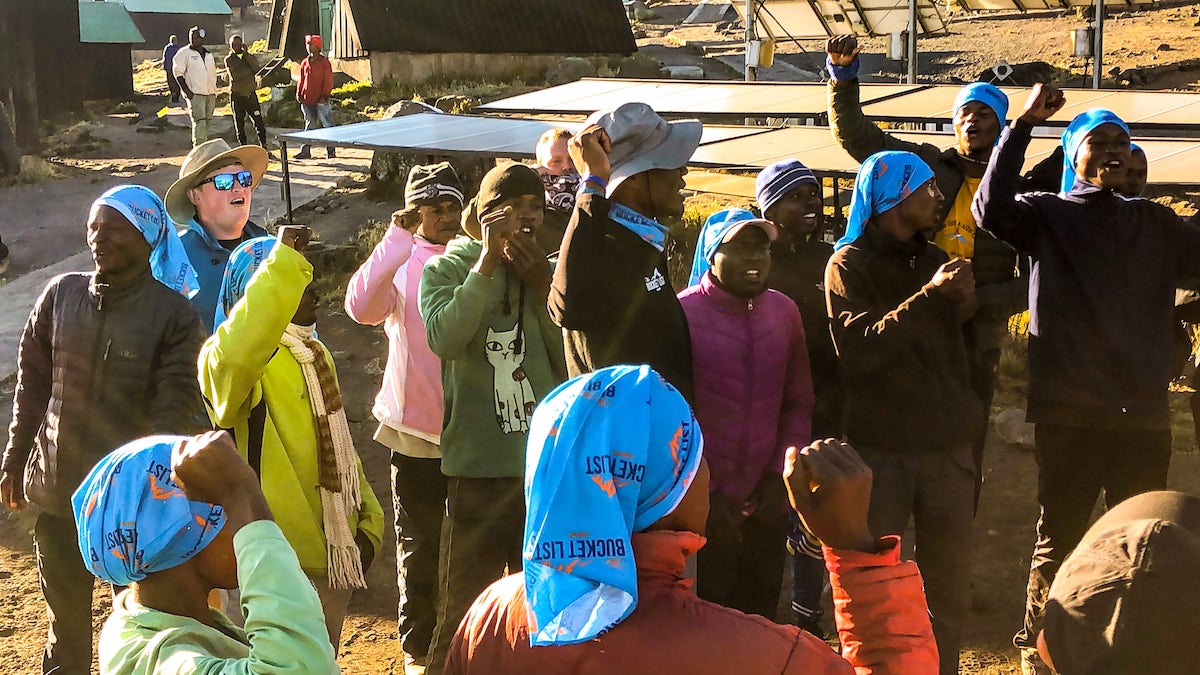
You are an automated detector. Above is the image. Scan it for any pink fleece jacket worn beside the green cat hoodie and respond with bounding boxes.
[346,226,445,443]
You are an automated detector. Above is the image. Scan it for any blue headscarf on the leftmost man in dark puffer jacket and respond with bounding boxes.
[91,185,200,298]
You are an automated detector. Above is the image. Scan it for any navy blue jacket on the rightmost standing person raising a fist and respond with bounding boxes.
[972,121,1200,430]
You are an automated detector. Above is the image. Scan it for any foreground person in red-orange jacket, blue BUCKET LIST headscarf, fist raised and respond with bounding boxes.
[446,365,937,675]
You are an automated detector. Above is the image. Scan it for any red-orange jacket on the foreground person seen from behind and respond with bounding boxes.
[445,531,937,675]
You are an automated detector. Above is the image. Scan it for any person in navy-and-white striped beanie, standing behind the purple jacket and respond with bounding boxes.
[755,160,842,637]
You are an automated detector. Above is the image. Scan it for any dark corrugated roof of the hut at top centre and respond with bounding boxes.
[346,0,637,54]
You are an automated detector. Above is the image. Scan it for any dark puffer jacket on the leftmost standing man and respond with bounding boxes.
[2,268,203,518]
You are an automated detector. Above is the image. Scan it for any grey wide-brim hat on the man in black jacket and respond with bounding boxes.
[584,103,704,197]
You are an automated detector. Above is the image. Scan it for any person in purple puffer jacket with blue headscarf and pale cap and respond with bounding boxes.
[679,209,814,620]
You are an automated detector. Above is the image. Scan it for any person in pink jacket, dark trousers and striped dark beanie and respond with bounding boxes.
[346,162,463,667]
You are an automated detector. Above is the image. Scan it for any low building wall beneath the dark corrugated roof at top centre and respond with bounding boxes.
[345,52,604,83]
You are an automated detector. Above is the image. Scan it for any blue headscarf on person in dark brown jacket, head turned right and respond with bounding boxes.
[834,150,934,250]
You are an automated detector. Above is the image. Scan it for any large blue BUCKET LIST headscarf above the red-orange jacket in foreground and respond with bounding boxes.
[523,365,703,646]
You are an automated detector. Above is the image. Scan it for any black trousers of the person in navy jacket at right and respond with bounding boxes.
[1013,424,1171,649]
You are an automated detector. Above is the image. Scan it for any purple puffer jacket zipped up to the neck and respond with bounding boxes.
[679,274,814,504]
